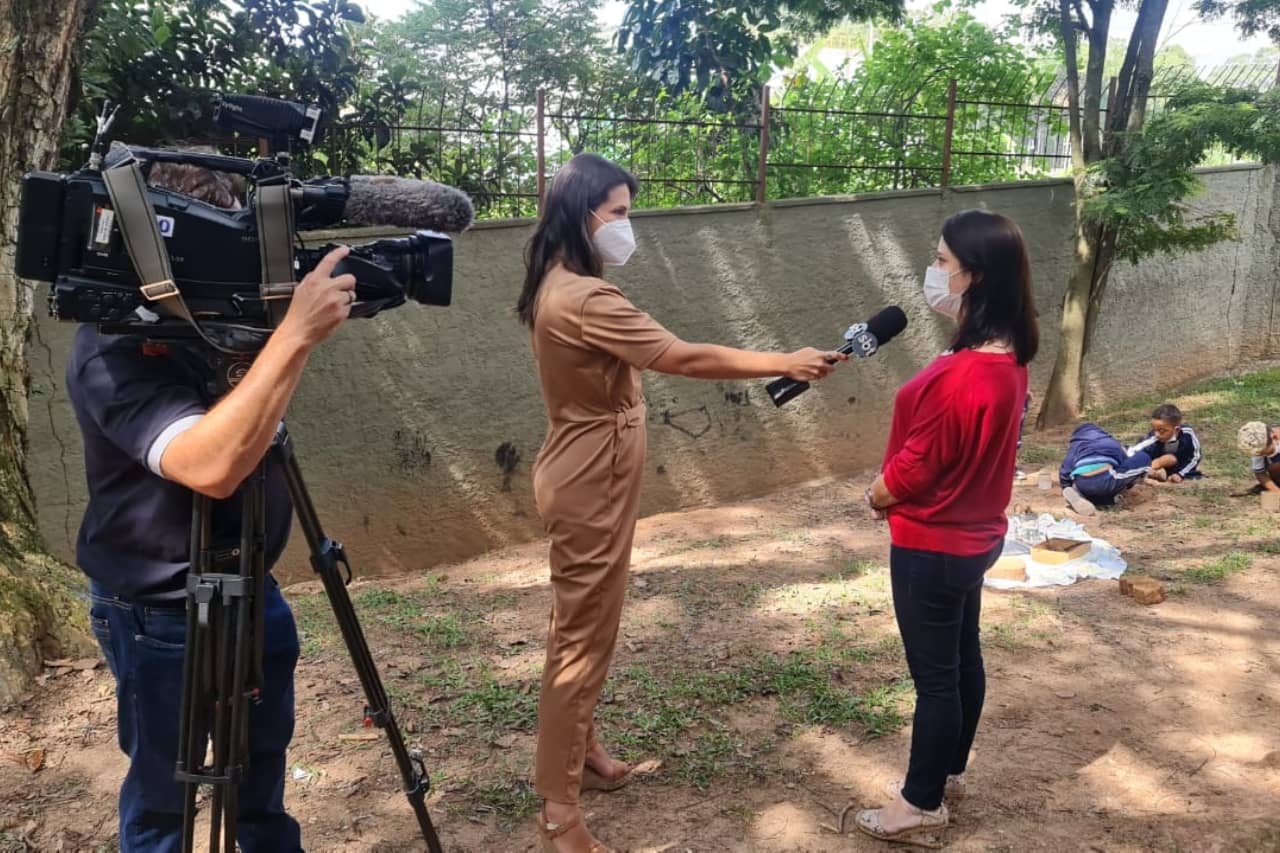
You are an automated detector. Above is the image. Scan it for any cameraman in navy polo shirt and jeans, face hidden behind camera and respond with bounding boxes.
[67,154,356,853]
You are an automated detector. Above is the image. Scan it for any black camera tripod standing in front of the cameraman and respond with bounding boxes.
[175,420,442,853]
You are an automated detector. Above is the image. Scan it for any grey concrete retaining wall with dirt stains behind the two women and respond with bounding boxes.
[31,168,1280,575]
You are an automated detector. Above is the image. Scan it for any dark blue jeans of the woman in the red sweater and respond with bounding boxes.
[890,544,1002,809]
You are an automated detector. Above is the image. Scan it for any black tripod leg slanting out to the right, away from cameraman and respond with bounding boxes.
[271,425,443,853]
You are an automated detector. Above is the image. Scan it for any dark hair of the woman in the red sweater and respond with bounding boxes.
[942,210,1039,364]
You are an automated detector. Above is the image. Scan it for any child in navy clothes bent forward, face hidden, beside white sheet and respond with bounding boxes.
[1057,424,1151,515]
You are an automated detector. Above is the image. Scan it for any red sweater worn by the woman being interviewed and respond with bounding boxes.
[883,350,1027,557]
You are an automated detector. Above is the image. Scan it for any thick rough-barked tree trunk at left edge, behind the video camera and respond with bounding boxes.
[0,0,93,704]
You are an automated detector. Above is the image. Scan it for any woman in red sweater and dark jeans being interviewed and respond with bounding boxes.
[858,210,1039,845]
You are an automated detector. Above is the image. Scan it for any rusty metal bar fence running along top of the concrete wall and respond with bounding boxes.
[315,65,1276,219]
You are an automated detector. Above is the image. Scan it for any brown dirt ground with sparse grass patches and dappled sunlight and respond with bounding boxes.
[0,409,1280,853]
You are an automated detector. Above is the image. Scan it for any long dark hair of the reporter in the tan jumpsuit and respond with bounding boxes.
[516,154,640,327]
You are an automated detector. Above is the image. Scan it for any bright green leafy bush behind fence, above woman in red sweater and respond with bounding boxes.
[769,14,1065,197]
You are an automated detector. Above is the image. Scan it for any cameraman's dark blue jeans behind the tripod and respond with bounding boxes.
[90,583,302,853]
